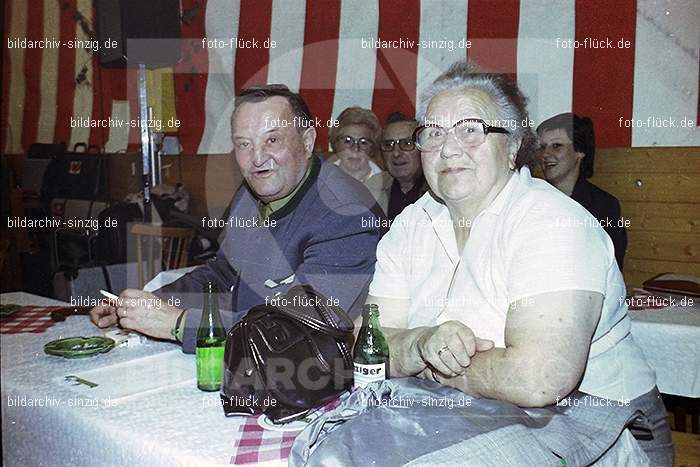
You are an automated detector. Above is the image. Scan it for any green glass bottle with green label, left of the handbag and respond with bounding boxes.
[196,282,226,391]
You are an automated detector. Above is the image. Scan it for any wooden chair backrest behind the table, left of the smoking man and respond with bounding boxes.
[131,223,194,288]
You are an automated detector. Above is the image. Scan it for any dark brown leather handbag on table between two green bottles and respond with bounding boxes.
[221,286,354,423]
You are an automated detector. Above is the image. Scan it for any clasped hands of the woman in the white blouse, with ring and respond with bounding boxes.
[415,321,494,376]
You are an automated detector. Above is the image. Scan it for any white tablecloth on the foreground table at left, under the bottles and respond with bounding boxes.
[0,293,262,466]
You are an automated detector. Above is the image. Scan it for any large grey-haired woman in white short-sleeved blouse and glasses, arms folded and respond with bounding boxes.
[367,63,673,465]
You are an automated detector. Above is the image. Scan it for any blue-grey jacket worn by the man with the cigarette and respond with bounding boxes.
[155,157,382,353]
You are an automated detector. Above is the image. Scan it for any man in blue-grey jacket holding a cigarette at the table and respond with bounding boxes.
[91,85,379,353]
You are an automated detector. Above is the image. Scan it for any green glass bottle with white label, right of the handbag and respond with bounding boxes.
[353,304,389,388]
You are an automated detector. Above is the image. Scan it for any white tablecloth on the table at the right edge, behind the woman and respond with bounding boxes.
[630,308,700,397]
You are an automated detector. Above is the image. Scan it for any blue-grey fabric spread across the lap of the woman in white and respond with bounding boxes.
[289,378,647,466]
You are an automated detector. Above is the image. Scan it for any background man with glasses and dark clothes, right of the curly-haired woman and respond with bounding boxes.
[366,112,428,221]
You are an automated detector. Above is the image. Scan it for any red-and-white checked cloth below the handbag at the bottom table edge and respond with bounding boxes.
[231,398,341,465]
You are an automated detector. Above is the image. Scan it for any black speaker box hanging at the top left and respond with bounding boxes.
[95,0,180,68]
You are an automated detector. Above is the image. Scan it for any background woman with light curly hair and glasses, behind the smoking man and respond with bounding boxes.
[328,107,382,183]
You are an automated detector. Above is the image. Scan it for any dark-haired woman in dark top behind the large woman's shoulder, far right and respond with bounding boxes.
[537,112,627,271]
